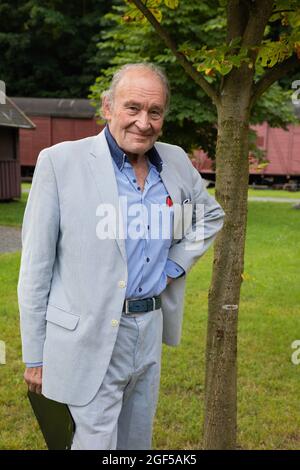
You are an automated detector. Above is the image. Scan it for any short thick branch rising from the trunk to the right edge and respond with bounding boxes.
[251,54,300,105]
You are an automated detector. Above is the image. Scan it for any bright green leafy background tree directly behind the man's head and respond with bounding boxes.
[90,0,295,159]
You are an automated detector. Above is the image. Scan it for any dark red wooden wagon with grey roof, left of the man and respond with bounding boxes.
[14,98,103,176]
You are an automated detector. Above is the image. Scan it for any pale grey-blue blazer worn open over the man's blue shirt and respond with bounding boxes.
[18,127,224,406]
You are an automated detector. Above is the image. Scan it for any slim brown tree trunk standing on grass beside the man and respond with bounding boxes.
[204,72,251,449]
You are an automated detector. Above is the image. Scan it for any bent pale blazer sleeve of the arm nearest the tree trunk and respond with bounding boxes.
[168,155,225,273]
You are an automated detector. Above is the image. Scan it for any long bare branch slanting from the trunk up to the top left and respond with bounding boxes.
[132,0,220,105]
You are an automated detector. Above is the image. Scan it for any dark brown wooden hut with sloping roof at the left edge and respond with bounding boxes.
[0,97,35,201]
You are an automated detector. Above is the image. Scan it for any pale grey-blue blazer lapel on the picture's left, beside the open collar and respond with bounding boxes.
[88,130,127,262]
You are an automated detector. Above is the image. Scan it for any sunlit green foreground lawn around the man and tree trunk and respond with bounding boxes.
[0,195,300,449]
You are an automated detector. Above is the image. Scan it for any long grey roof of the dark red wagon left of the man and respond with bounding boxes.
[13,97,95,119]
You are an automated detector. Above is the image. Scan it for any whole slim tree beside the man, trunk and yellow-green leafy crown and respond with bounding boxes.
[92,0,300,449]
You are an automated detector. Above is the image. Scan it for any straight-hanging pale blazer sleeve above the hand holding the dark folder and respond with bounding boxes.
[17,150,60,363]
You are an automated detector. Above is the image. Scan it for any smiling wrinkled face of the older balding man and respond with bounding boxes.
[103,69,166,156]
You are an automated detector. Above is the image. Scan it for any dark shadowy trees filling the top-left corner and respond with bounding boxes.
[0,0,112,98]
